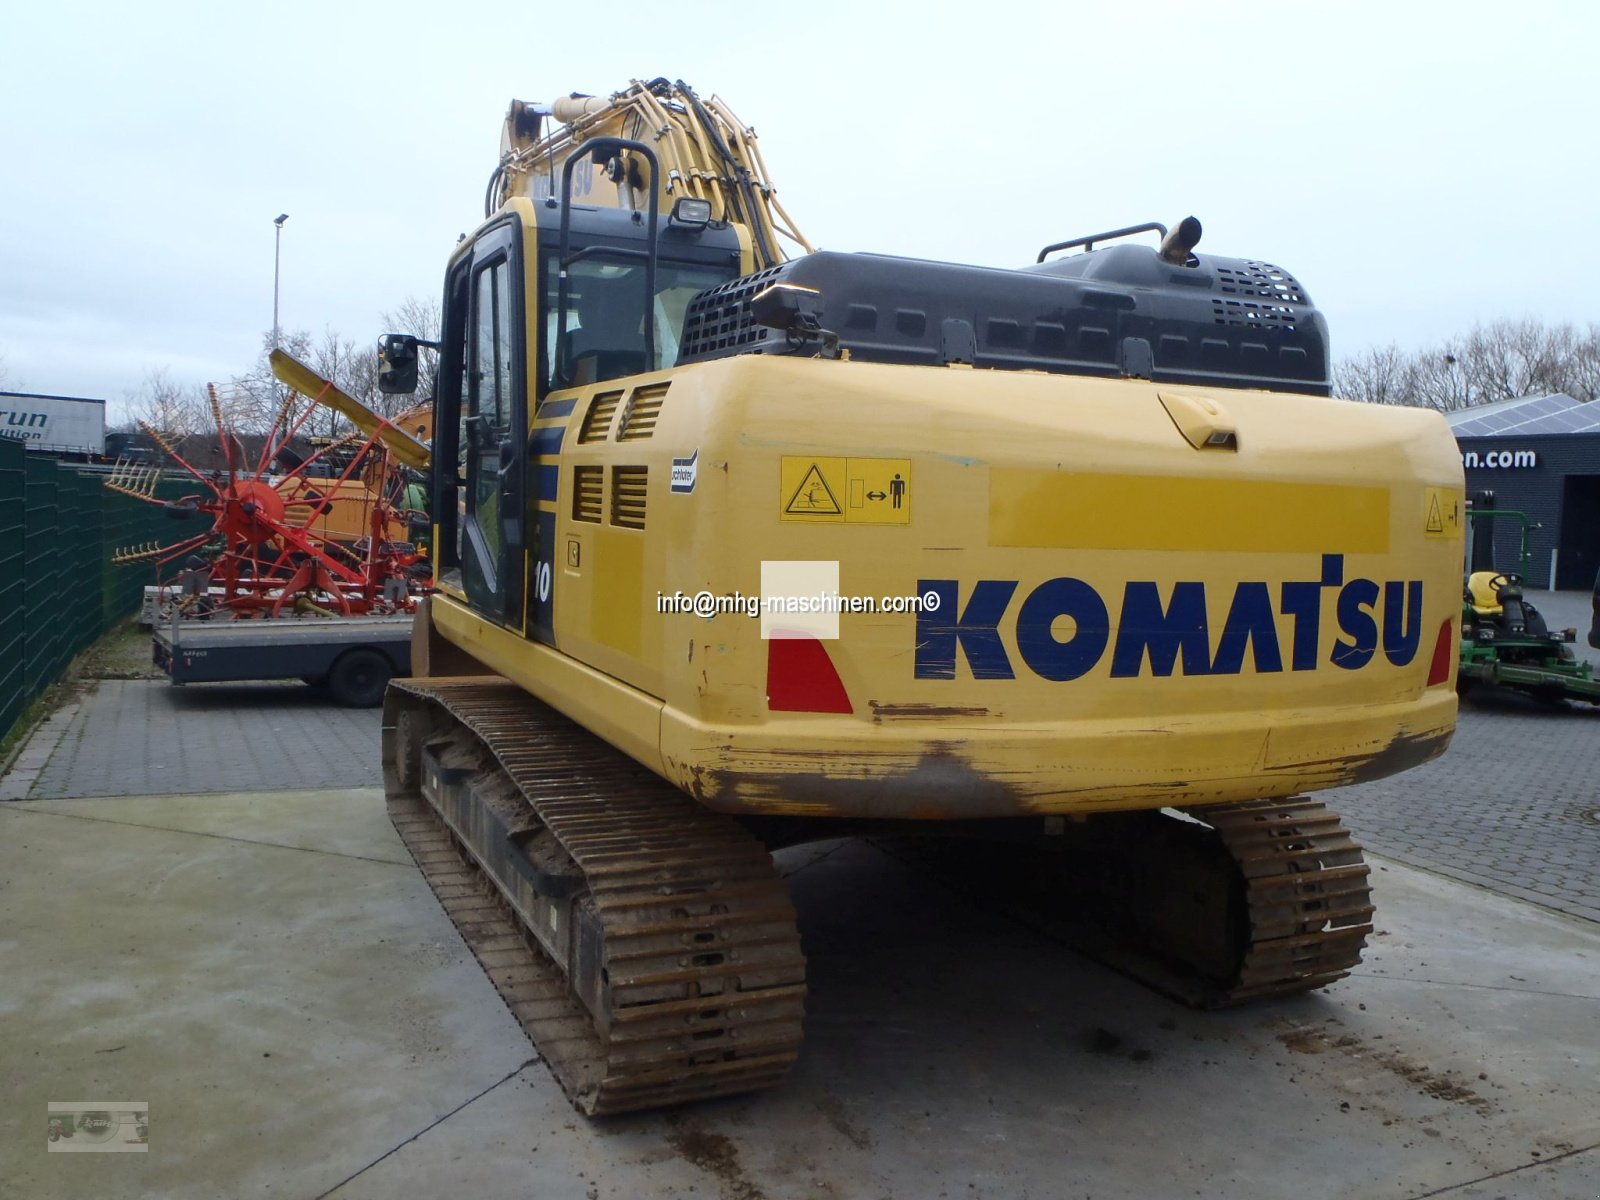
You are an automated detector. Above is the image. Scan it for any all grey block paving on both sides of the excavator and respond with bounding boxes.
[12,592,1600,920]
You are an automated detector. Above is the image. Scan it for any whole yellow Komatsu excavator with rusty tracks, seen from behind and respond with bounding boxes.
[382,78,1464,1114]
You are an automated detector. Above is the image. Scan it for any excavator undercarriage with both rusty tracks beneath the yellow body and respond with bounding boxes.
[384,677,1373,1115]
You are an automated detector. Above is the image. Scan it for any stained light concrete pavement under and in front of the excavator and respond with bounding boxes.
[0,789,1600,1200]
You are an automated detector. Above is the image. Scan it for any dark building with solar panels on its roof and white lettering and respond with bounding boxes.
[1446,392,1600,590]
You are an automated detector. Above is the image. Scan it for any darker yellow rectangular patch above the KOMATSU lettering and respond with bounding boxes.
[989,469,1389,554]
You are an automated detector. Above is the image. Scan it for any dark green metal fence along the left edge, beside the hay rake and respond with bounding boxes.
[0,438,189,738]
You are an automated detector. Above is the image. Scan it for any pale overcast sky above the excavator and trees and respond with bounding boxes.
[0,0,1600,419]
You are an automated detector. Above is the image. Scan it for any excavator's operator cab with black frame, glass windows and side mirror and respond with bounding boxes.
[419,139,744,624]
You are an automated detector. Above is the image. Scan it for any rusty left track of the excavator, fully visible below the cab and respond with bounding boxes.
[384,677,805,1115]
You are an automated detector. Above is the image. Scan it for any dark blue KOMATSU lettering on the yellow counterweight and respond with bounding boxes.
[915,554,1422,682]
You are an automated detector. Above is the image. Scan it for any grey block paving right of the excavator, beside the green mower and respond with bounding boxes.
[1326,592,1600,922]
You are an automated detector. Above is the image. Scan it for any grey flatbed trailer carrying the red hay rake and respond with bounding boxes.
[152,614,411,707]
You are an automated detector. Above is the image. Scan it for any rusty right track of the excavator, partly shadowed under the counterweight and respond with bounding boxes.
[878,797,1373,1010]
